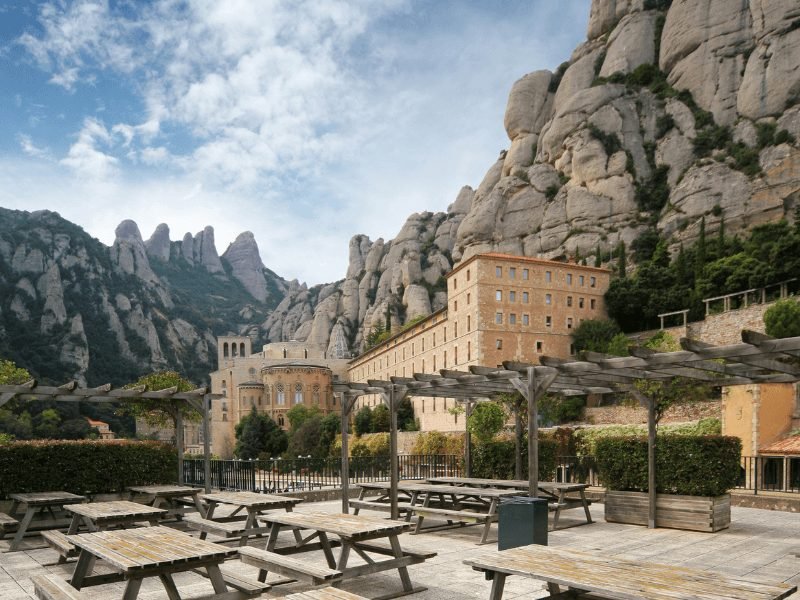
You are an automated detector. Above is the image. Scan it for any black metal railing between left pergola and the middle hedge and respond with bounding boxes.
[183,454,463,493]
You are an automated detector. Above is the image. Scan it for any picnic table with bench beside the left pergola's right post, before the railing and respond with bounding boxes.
[185,492,303,546]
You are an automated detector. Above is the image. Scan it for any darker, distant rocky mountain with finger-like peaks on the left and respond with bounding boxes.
[0,209,288,385]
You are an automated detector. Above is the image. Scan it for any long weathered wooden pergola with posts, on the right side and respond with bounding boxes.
[333,331,800,528]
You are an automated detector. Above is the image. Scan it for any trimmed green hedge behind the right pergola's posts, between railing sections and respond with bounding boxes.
[472,438,558,481]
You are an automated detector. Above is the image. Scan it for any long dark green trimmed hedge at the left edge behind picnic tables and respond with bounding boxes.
[0,440,178,498]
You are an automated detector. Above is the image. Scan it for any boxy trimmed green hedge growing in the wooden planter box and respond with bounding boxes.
[596,435,742,496]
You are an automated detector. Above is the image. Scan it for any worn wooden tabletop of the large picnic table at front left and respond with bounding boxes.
[69,527,237,574]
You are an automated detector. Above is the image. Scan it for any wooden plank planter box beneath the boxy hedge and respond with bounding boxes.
[605,490,731,532]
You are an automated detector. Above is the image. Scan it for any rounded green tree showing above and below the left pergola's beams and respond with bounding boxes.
[119,371,202,446]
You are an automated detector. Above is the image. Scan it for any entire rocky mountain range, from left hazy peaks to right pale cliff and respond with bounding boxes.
[7,0,800,383]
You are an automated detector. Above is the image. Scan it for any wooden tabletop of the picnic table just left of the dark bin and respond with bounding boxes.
[259,512,412,538]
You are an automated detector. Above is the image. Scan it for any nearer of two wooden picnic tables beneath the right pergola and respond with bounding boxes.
[351,481,519,544]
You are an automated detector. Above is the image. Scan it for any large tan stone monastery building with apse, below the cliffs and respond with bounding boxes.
[211,253,610,457]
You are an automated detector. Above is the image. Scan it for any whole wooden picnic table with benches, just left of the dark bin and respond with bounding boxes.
[248,512,436,600]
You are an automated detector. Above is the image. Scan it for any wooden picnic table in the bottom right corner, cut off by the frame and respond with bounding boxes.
[464,544,797,600]
